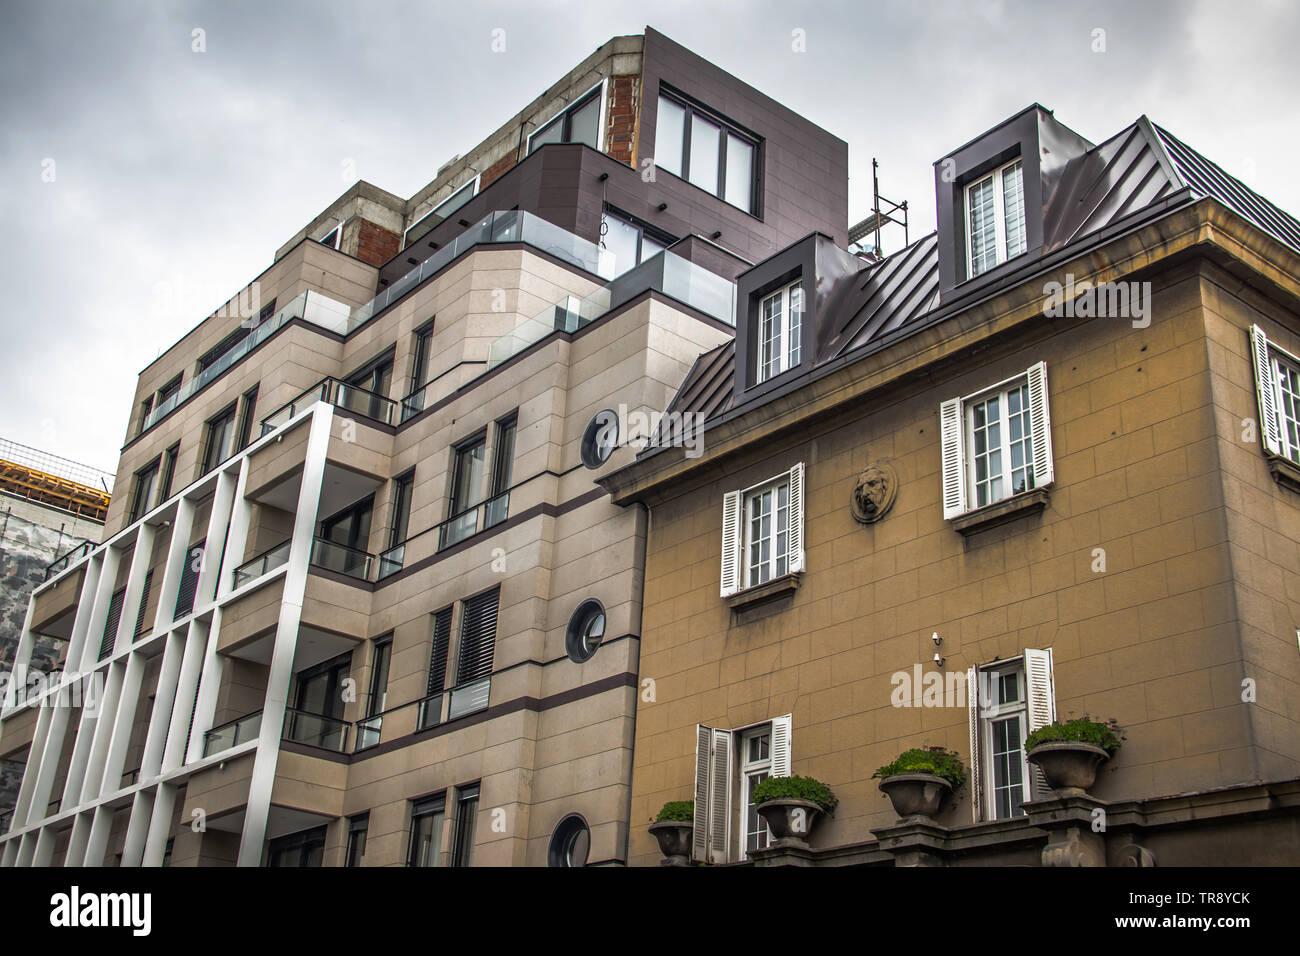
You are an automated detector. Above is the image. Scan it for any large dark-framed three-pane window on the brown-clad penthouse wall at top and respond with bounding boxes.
[654,92,759,215]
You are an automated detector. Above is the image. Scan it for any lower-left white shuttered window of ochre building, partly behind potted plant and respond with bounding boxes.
[692,714,793,862]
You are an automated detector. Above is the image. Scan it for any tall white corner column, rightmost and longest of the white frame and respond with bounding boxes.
[237,402,334,866]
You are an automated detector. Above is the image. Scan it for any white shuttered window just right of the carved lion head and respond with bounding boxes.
[939,362,1054,519]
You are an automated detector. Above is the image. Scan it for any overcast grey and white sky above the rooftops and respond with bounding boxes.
[0,0,1300,471]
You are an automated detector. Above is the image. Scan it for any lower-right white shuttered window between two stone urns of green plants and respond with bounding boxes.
[966,648,1056,822]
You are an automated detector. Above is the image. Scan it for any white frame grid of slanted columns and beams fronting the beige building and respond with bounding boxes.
[0,402,334,866]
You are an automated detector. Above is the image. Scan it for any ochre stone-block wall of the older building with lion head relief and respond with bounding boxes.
[631,261,1300,865]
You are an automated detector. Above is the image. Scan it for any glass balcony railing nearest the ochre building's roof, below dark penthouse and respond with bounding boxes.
[486,251,736,371]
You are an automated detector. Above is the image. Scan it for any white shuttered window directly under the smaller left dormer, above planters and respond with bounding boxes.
[722,462,803,597]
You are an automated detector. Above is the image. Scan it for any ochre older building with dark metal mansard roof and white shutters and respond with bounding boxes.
[599,105,1300,866]
